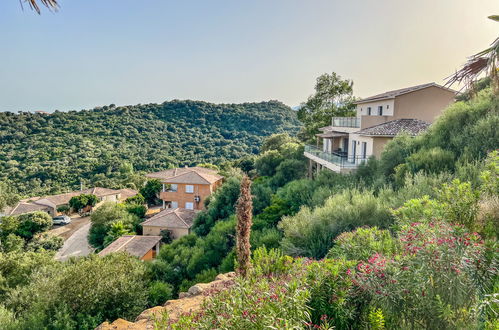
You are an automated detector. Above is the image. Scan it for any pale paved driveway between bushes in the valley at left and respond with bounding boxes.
[52,217,93,261]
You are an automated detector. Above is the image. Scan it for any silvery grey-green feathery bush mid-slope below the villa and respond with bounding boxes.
[279,190,393,259]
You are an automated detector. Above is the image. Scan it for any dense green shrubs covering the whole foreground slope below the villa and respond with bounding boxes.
[0,84,499,329]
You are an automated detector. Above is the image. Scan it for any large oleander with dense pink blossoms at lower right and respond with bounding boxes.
[352,222,497,329]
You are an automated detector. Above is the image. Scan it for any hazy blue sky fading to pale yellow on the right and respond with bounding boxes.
[0,0,499,112]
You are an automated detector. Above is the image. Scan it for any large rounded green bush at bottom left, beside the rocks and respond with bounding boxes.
[6,253,148,329]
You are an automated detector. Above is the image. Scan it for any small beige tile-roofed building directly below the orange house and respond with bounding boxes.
[142,208,196,239]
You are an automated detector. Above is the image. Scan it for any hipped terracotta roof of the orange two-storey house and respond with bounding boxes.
[146,167,223,184]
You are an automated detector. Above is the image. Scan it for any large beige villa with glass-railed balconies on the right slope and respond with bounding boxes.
[304,83,456,176]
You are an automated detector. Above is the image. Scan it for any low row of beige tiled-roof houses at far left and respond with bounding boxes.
[0,187,137,217]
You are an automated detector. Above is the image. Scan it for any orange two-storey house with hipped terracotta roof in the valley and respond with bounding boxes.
[146,167,223,210]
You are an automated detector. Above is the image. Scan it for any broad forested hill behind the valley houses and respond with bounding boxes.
[0,100,299,196]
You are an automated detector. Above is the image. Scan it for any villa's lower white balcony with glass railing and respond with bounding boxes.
[304,145,367,173]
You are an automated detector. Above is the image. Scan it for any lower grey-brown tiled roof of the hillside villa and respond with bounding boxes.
[354,119,430,136]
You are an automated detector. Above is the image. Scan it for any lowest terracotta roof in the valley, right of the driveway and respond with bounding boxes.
[99,235,161,258]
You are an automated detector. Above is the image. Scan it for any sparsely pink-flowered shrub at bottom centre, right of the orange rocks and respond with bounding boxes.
[166,276,310,329]
